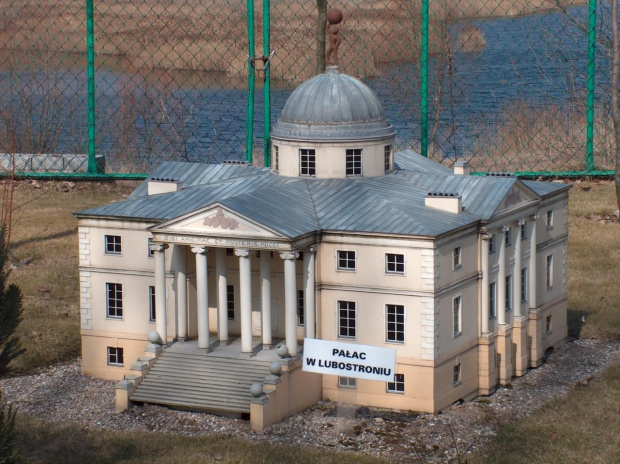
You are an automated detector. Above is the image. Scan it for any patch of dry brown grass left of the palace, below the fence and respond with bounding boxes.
[5,182,135,372]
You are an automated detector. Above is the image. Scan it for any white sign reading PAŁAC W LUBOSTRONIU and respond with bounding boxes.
[303,338,396,382]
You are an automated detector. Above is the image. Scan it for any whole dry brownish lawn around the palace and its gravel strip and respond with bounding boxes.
[1,178,620,464]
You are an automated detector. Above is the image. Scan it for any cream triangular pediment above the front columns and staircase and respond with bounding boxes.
[150,203,284,239]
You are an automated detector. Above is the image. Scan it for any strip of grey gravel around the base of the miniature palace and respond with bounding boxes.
[0,340,620,462]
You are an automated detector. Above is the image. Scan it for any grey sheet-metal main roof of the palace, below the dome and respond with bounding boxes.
[76,152,568,238]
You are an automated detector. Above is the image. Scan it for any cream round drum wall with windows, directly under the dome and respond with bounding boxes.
[272,137,394,179]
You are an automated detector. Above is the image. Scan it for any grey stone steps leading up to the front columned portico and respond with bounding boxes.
[130,350,270,414]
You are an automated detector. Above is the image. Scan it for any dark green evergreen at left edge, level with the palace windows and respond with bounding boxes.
[0,227,25,375]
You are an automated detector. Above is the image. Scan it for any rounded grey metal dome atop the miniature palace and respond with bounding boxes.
[272,66,395,141]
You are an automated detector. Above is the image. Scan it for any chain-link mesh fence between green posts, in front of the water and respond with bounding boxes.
[0,0,614,173]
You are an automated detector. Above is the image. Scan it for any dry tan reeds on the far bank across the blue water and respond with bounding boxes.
[0,0,585,81]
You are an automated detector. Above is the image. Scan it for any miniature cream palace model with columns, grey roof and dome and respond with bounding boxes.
[76,37,568,430]
